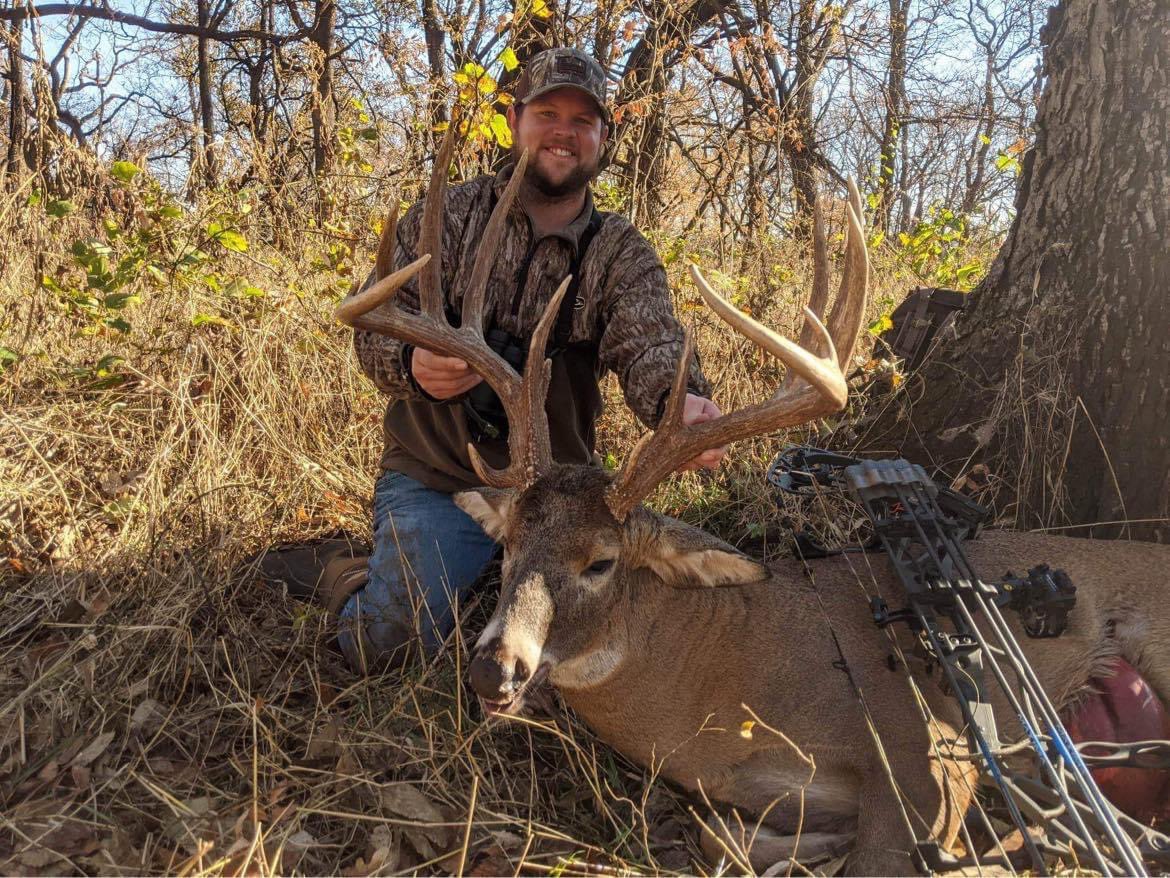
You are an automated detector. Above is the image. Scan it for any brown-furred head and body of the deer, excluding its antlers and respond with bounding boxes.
[456,466,1170,874]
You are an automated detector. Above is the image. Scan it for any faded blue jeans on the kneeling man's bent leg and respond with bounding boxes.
[340,469,496,670]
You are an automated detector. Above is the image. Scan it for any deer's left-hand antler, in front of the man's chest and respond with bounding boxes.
[336,122,570,488]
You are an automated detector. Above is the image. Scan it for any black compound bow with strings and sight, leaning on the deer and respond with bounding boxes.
[768,446,1170,874]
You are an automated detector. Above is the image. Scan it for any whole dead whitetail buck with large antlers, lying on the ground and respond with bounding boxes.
[338,137,1170,874]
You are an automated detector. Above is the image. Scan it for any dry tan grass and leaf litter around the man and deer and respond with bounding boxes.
[0,160,921,874]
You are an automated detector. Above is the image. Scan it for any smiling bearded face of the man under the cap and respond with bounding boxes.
[508,88,608,198]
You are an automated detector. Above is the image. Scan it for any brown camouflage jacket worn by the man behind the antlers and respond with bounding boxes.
[353,166,710,492]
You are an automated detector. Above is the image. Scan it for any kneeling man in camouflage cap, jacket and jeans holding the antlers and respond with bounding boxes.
[263,48,723,671]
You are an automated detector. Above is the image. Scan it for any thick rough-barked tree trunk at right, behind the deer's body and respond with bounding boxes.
[872,0,1170,541]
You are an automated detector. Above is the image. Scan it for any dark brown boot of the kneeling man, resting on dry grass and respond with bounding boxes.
[257,540,370,612]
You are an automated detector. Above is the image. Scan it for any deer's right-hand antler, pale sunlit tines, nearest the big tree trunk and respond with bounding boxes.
[606,180,869,521]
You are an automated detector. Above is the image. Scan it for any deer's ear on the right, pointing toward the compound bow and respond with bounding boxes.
[634,514,768,589]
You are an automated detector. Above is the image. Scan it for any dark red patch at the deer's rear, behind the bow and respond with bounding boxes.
[1065,658,1170,823]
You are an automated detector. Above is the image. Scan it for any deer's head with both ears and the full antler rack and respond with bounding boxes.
[337,128,868,713]
